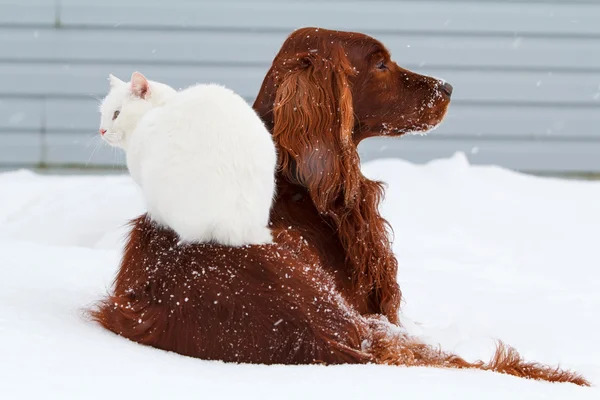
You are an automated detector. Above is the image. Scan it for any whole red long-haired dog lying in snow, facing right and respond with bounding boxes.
[93,28,587,385]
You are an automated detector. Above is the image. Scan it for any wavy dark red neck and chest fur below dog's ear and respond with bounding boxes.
[267,152,401,323]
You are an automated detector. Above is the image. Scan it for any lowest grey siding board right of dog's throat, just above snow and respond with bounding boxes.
[360,135,600,173]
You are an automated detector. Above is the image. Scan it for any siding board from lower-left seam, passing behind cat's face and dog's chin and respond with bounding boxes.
[46,99,600,141]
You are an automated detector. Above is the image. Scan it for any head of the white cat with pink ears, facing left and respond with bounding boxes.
[99,72,175,148]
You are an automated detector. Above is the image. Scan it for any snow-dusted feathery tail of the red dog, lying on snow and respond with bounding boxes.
[365,317,590,386]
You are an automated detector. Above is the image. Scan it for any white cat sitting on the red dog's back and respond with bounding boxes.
[100,72,277,246]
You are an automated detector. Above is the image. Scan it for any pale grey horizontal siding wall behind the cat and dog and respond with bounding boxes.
[0,0,600,172]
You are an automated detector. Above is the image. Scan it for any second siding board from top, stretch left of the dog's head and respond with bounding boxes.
[0,28,278,66]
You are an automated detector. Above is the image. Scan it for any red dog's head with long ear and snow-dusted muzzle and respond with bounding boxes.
[254,28,452,211]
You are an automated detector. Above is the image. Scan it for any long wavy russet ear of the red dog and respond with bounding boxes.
[272,46,361,212]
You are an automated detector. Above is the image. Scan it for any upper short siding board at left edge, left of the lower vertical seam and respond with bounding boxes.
[0,99,44,132]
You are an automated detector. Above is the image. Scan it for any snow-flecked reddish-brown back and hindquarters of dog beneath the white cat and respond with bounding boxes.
[93,216,370,364]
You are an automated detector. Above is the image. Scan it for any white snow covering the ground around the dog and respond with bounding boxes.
[0,154,600,399]
